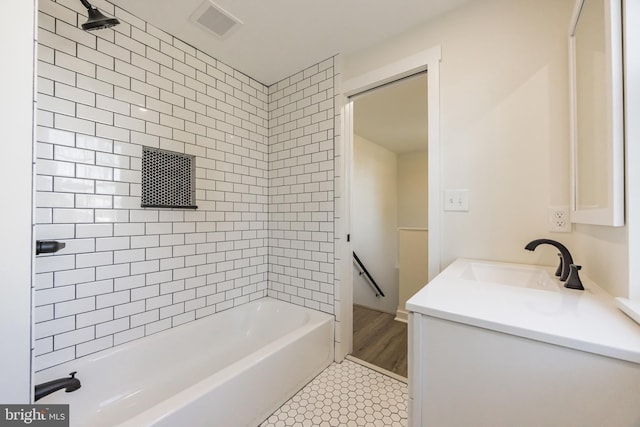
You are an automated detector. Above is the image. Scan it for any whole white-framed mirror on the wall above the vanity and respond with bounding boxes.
[569,0,624,226]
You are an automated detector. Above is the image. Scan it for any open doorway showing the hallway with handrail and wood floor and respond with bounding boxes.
[350,71,428,377]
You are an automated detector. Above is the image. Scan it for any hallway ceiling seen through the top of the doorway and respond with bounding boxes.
[353,73,427,154]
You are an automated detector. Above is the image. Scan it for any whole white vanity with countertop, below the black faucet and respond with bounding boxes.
[407,260,640,427]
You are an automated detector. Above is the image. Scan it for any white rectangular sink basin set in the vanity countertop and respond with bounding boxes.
[460,262,560,291]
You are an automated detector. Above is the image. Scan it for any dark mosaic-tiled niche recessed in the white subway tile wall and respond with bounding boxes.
[142,147,197,209]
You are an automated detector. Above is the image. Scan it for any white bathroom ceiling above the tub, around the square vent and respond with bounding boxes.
[110,0,468,86]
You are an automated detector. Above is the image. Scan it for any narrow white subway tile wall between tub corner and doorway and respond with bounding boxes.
[269,58,337,314]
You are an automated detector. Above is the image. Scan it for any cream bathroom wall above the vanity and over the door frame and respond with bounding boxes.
[343,0,627,294]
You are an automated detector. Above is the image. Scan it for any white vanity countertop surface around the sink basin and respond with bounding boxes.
[407,259,640,363]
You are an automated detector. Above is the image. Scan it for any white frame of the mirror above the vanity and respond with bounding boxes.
[569,0,624,227]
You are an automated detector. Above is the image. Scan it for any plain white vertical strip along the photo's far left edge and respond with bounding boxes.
[0,0,38,404]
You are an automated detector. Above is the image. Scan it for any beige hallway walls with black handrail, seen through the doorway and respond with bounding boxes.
[352,141,428,313]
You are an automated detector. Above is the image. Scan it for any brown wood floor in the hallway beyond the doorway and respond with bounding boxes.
[352,305,407,377]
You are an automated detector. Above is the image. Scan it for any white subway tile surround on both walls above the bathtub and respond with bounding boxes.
[34,0,278,370]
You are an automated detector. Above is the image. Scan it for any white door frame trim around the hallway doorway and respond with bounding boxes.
[335,46,442,360]
